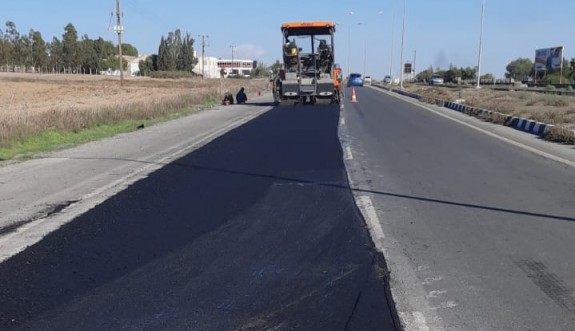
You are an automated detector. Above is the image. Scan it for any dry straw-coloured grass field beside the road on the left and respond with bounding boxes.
[0,73,268,152]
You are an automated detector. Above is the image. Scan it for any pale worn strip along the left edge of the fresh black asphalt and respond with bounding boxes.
[0,107,272,263]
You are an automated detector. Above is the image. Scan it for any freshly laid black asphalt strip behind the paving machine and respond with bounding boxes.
[0,105,395,330]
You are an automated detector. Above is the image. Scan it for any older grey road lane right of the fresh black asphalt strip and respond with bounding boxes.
[340,87,575,330]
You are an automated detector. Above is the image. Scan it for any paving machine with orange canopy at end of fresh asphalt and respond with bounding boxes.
[274,22,341,104]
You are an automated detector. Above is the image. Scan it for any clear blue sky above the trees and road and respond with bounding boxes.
[0,0,575,79]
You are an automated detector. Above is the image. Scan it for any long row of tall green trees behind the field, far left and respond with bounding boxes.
[0,21,138,74]
